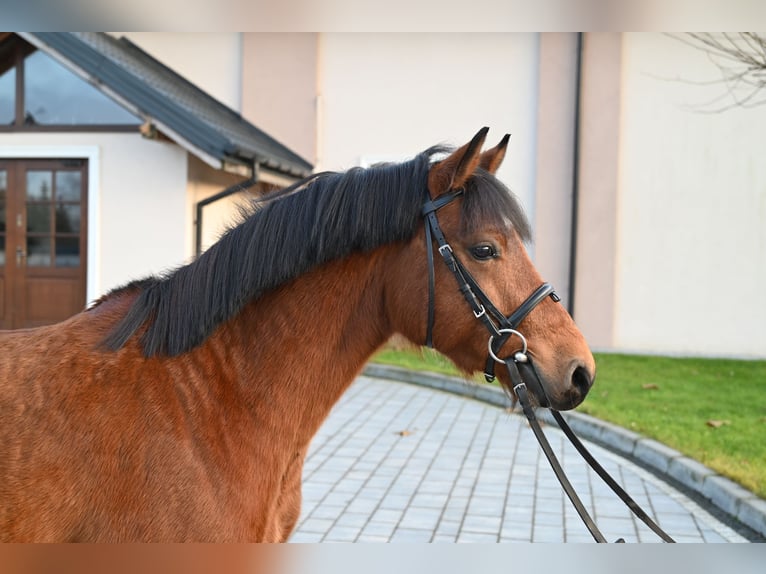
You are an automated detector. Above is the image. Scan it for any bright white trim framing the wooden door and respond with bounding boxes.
[0,145,101,303]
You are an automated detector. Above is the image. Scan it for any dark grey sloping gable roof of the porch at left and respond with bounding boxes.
[19,32,312,177]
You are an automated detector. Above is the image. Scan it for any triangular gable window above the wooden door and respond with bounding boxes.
[0,35,141,130]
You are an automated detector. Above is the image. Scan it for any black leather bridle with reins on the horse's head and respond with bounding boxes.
[422,190,675,542]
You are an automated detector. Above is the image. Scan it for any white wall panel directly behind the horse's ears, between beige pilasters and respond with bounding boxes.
[316,33,539,233]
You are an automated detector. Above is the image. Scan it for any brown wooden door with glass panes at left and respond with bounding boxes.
[0,160,88,329]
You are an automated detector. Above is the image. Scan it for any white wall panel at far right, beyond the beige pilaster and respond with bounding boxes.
[615,34,766,357]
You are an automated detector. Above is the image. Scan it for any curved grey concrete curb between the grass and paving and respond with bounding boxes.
[364,363,766,537]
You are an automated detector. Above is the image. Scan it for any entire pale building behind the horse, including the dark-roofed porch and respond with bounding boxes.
[0,33,766,358]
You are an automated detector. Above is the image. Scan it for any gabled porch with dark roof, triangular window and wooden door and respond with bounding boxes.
[0,33,312,329]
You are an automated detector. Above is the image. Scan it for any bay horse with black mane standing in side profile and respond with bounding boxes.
[0,128,595,542]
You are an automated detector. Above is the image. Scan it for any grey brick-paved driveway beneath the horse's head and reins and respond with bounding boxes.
[291,376,746,542]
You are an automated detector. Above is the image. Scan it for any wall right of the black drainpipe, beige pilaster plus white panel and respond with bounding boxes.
[574,33,766,358]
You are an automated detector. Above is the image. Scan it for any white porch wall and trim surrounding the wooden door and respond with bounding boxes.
[0,133,187,301]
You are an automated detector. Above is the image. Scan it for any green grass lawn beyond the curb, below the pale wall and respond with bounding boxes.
[373,349,766,498]
